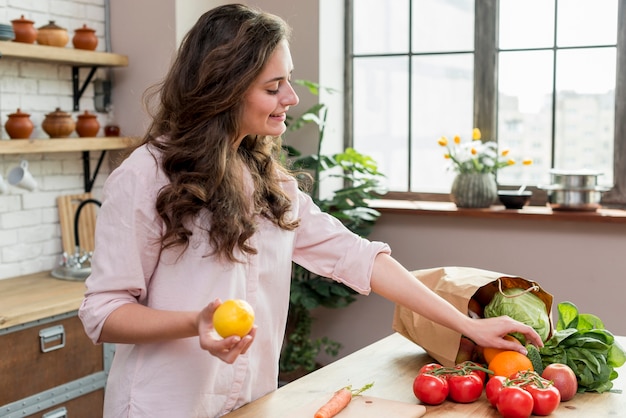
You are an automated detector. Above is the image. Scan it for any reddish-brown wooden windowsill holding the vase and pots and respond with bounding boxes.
[370,199,626,224]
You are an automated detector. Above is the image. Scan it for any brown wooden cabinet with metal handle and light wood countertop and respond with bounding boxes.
[0,272,113,418]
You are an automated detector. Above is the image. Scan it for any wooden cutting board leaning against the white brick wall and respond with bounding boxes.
[57,193,98,254]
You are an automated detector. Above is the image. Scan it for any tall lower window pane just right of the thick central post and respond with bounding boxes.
[497,51,553,185]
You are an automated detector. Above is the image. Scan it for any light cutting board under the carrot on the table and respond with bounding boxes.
[285,394,426,418]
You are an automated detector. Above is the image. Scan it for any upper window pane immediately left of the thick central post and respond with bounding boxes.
[412,0,474,53]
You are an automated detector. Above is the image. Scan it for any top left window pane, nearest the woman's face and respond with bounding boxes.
[353,0,409,55]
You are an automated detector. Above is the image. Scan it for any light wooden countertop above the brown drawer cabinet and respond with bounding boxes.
[0,271,85,329]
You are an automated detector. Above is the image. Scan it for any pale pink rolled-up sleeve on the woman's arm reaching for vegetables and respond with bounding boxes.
[293,188,391,295]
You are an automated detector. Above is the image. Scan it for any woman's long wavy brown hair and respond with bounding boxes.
[144,4,299,262]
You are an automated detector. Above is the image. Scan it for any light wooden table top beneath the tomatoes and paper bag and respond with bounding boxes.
[225,334,626,418]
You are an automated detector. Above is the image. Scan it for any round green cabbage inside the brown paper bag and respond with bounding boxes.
[484,288,551,343]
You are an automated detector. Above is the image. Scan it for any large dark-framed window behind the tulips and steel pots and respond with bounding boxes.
[346,0,626,204]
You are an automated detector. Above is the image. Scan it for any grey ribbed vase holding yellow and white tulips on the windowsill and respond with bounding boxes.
[450,173,498,208]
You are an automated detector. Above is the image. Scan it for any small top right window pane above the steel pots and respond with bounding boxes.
[557,0,617,47]
